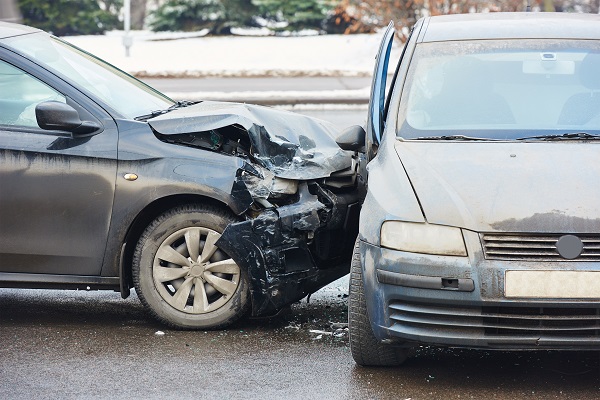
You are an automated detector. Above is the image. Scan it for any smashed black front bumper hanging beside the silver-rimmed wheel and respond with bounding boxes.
[217,182,360,316]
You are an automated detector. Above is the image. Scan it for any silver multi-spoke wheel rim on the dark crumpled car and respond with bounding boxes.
[152,227,240,314]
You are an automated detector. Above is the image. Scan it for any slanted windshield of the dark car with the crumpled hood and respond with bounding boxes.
[2,33,174,118]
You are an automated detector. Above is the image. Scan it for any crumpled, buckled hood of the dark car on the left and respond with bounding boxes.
[148,101,352,179]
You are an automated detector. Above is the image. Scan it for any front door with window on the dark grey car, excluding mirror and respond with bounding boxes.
[0,54,118,280]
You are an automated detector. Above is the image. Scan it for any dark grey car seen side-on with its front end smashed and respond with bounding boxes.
[0,23,364,329]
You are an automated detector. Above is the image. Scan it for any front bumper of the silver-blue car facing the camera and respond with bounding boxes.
[360,231,600,350]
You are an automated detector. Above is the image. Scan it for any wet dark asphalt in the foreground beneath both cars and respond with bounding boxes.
[0,280,600,400]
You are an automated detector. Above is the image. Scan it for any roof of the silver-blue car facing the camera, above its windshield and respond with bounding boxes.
[418,12,600,42]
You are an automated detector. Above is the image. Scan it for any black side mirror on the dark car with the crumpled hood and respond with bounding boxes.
[35,101,101,135]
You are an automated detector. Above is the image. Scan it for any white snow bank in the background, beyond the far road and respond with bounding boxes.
[63,31,400,77]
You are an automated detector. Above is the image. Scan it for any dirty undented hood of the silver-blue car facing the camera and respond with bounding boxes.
[395,141,600,233]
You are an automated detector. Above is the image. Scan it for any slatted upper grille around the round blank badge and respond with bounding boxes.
[481,234,600,261]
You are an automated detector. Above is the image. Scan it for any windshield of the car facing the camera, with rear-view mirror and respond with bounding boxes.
[398,39,600,140]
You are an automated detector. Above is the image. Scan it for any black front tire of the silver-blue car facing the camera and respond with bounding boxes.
[348,239,409,367]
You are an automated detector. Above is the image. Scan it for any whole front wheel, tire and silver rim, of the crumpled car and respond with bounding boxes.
[132,204,250,329]
